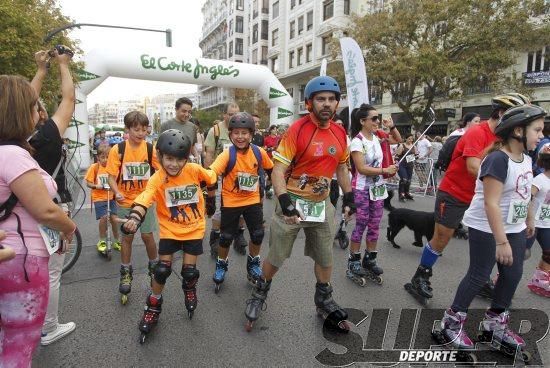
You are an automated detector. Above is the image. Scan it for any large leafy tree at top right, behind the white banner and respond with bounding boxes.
[348,0,550,128]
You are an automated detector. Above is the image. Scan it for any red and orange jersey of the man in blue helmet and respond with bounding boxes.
[273,114,349,202]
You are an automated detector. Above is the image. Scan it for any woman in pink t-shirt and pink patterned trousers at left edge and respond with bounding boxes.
[0,75,76,367]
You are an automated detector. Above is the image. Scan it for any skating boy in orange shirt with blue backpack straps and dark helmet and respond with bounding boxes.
[209,112,273,292]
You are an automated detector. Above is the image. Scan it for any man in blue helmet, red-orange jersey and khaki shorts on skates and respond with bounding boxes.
[245,76,354,331]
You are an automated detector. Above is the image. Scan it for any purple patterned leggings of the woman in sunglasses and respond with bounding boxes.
[351,189,384,243]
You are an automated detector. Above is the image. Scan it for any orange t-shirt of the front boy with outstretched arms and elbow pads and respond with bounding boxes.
[134,163,217,240]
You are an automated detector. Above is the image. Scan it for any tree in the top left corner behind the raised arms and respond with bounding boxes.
[0,0,78,111]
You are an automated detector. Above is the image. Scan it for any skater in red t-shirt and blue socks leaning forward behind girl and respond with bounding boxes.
[405,93,529,305]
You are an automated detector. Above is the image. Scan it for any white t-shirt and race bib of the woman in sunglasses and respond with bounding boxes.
[350,133,385,190]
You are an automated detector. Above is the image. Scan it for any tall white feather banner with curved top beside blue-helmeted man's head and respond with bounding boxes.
[340,37,370,115]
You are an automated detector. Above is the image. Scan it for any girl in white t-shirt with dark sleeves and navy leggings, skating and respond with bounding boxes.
[441,105,546,355]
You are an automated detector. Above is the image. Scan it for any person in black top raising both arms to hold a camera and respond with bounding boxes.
[29,45,76,345]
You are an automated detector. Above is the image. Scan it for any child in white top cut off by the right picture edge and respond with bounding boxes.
[527,143,550,298]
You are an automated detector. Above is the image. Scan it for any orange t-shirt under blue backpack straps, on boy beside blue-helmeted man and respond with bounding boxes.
[210,147,273,207]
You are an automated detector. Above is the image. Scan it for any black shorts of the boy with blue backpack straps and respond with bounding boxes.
[220,203,264,234]
